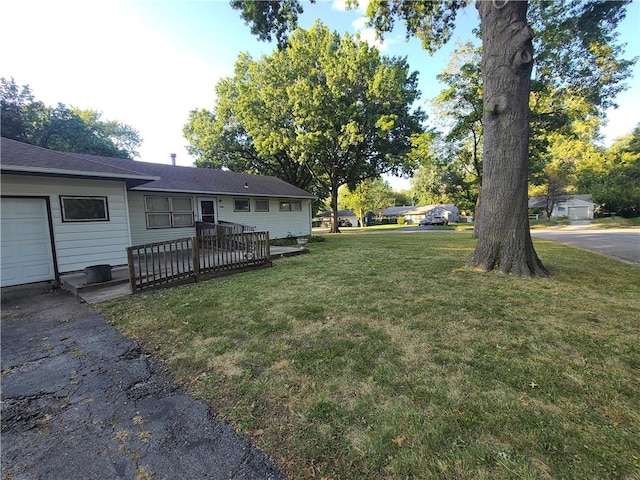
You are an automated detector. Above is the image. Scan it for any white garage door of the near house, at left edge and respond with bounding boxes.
[0,198,55,287]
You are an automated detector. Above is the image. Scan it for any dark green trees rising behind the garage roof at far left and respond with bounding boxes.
[0,78,142,158]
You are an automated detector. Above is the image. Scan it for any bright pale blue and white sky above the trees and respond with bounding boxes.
[0,0,640,189]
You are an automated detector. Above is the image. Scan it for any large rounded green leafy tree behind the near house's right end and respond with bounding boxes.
[185,23,423,232]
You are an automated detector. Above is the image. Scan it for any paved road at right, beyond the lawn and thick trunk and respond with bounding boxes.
[531,225,640,266]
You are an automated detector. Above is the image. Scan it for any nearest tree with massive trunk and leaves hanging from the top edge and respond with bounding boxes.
[231,0,628,275]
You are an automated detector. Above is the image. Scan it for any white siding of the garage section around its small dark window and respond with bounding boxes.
[1,174,129,273]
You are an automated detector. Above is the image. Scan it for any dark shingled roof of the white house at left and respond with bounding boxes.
[1,138,315,198]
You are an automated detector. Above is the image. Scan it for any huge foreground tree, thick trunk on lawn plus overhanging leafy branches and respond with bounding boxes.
[236,0,629,275]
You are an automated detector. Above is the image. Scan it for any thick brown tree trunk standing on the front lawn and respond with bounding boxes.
[468,0,547,276]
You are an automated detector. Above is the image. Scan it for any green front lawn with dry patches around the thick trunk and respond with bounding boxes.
[99,233,640,480]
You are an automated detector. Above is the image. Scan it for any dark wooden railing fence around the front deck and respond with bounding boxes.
[127,232,271,293]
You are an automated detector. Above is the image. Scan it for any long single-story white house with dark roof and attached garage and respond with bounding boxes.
[0,138,315,286]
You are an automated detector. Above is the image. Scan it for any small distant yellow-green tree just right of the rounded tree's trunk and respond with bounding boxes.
[338,178,395,225]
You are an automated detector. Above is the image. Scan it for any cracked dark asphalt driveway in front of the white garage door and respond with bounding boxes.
[1,284,283,480]
